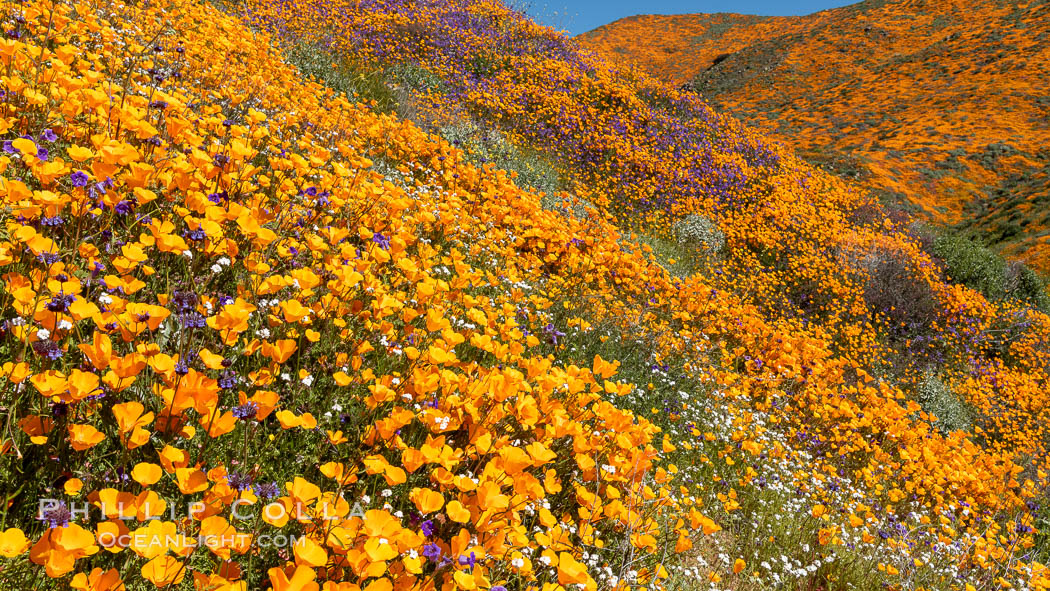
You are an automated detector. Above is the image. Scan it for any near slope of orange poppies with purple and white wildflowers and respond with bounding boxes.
[0,0,1050,591]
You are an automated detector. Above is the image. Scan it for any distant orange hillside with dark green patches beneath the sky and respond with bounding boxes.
[580,0,1050,271]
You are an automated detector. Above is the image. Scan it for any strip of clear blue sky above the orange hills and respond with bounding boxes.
[520,0,858,35]
